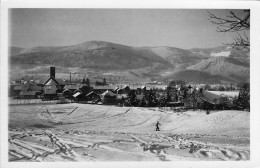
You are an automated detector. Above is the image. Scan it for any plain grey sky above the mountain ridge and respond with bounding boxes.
[9,9,248,49]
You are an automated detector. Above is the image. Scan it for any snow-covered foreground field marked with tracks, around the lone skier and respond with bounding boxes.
[9,104,250,161]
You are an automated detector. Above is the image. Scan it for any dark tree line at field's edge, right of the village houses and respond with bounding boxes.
[121,80,250,110]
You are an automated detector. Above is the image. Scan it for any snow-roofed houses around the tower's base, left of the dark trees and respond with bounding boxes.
[9,77,158,98]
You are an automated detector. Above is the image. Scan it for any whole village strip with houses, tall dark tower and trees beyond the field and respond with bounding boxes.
[9,67,250,111]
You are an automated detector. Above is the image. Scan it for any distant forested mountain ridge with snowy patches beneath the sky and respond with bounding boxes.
[10,41,250,82]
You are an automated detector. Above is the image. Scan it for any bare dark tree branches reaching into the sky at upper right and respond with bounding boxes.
[208,9,250,50]
